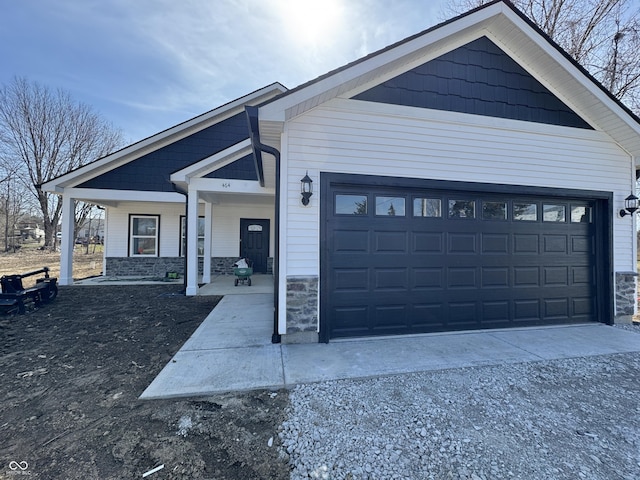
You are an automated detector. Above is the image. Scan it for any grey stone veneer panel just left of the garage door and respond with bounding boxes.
[287,276,318,335]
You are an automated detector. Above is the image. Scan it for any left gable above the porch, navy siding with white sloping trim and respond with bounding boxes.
[42,83,286,192]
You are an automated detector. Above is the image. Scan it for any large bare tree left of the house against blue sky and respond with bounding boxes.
[0,77,123,246]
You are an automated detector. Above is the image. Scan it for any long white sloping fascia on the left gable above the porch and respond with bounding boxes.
[42,83,287,192]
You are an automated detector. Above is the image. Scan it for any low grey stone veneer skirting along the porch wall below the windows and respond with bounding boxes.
[104,257,273,277]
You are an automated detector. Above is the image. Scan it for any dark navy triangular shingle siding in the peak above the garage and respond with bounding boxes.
[353,37,591,129]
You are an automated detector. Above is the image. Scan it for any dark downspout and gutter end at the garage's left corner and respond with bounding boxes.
[244,105,282,343]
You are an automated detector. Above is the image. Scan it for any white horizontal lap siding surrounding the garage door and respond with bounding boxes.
[282,99,635,275]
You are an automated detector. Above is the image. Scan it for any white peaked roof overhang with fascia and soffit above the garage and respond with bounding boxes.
[258,0,640,157]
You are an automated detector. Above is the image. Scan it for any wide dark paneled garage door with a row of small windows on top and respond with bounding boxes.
[321,176,606,341]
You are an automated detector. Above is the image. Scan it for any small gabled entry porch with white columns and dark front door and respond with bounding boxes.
[171,140,276,295]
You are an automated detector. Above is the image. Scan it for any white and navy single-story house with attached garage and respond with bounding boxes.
[45,1,640,342]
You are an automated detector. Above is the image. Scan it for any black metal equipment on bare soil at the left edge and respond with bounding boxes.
[0,267,58,314]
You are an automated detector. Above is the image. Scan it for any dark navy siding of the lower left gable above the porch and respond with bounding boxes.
[79,111,250,192]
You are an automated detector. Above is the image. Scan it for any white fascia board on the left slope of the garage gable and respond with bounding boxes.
[259,3,510,122]
